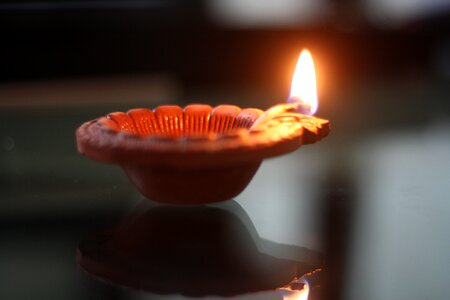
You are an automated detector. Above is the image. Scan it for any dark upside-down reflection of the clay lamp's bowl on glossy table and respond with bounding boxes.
[77,200,324,296]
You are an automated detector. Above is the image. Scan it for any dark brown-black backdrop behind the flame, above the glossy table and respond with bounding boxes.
[1,0,450,89]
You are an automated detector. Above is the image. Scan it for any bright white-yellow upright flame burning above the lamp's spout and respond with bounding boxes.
[288,49,318,115]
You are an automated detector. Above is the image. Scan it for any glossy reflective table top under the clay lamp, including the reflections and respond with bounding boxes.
[0,78,450,299]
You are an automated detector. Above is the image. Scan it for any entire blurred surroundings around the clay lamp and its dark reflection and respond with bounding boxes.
[0,0,450,299]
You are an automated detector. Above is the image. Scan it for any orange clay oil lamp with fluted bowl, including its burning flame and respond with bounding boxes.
[76,51,330,204]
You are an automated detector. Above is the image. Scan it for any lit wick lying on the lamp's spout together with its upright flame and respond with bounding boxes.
[250,49,318,130]
